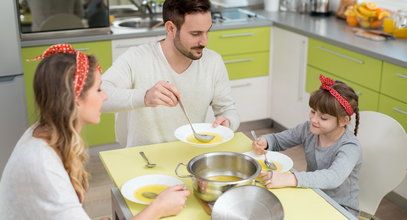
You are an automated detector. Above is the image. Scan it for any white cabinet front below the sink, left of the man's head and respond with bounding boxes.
[112,35,165,62]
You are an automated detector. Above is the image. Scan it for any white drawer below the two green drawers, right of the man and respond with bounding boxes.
[205,76,270,123]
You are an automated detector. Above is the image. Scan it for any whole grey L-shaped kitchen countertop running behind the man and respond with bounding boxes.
[21,10,407,68]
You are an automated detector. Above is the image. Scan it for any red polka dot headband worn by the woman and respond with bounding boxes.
[28,44,102,98]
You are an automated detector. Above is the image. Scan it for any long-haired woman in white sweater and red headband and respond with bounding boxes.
[0,44,190,220]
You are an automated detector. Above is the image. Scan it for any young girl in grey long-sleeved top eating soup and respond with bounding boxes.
[253,75,362,216]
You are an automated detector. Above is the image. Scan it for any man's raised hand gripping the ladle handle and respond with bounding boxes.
[144,81,180,107]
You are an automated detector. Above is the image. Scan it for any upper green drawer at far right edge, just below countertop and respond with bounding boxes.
[381,62,407,103]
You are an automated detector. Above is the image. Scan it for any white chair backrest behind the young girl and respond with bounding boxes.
[357,111,407,215]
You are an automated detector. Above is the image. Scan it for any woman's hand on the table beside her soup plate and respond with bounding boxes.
[151,185,191,217]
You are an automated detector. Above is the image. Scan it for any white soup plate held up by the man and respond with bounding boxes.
[174,123,234,147]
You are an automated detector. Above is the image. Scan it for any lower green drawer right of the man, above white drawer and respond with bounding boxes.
[222,52,269,80]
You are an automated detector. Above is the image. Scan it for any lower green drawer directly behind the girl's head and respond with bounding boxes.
[305,66,379,111]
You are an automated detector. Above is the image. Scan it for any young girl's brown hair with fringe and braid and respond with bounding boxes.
[309,80,359,135]
